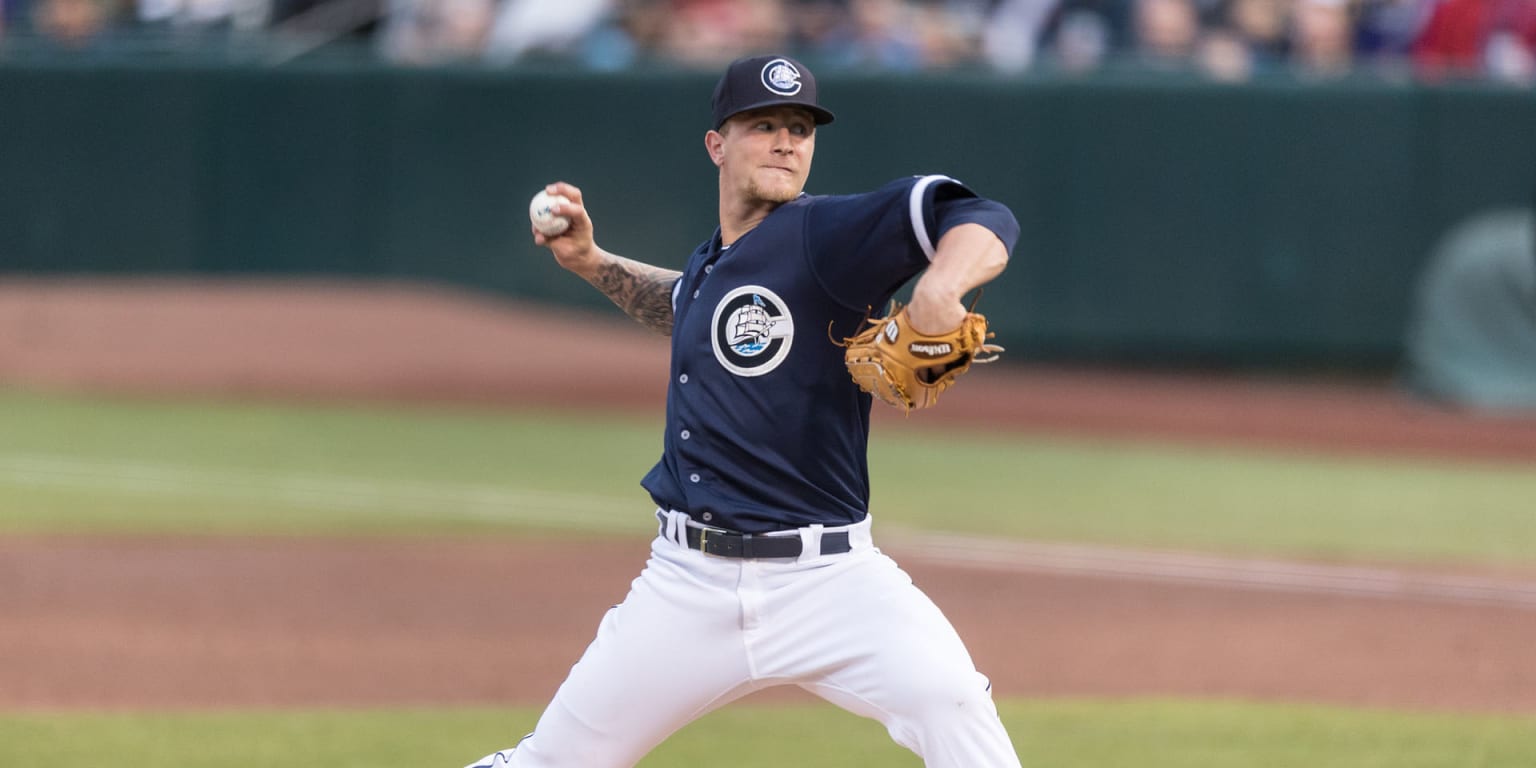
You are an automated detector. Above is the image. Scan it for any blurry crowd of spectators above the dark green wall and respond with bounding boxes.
[0,0,1536,84]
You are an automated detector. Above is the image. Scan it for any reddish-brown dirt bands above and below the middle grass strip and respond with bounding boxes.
[0,281,1536,711]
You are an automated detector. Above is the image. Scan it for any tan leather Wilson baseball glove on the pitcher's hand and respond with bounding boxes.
[839,301,1003,413]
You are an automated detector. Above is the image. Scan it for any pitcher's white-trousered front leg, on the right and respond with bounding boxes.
[803,554,1020,768]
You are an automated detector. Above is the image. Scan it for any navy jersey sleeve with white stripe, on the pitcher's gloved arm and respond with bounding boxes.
[806,175,1018,309]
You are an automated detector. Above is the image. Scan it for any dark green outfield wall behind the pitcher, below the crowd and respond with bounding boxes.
[0,63,1536,366]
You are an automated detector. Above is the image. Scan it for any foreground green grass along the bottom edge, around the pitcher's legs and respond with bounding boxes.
[0,700,1536,768]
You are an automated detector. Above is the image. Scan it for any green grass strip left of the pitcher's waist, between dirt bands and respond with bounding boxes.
[0,395,660,535]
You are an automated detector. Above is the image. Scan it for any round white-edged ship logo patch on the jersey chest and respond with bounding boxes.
[710,286,794,376]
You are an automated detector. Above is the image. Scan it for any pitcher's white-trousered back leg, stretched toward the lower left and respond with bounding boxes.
[466,542,751,768]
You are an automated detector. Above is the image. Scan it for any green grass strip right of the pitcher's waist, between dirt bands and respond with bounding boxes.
[872,436,1536,565]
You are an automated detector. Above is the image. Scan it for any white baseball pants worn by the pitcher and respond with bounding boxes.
[475,511,1020,768]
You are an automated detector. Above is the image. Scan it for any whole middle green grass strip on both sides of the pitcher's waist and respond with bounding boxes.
[0,393,1536,565]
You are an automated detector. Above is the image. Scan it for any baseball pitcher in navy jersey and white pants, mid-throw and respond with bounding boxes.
[472,55,1018,768]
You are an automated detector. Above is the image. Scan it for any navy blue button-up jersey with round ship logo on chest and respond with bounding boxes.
[641,177,1018,533]
